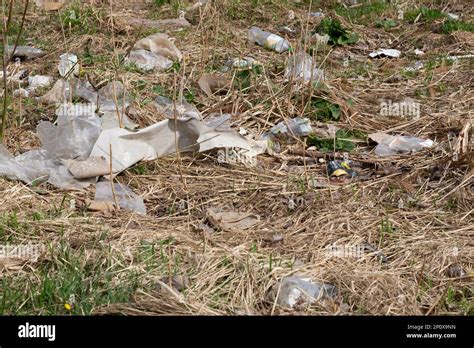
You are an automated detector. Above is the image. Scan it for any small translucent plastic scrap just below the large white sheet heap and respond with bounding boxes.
[94,181,146,215]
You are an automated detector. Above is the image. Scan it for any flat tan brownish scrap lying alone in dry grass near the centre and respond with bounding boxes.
[207,208,260,232]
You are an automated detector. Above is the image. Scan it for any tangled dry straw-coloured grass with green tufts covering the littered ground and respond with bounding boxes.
[0,0,474,315]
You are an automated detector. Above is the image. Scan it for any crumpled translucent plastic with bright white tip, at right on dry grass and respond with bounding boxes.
[369,133,434,156]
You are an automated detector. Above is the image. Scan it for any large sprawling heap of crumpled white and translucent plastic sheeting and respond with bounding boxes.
[0,78,258,189]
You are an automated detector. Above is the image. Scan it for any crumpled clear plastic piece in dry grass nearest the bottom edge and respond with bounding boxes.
[271,276,337,309]
